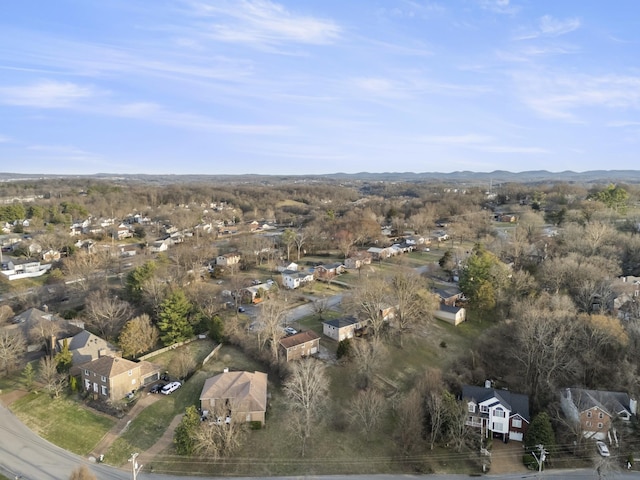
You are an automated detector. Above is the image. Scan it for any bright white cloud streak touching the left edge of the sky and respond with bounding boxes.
[0,80,99,108]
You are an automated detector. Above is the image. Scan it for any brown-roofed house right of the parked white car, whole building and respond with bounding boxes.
[200,369,267,423]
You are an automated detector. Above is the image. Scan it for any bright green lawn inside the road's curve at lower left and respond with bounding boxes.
[11,393,115,456]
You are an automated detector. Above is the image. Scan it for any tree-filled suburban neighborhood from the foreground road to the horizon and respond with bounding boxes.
[0,173,640,475]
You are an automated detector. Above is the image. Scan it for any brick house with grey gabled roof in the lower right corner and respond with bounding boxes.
[560,388,637,440]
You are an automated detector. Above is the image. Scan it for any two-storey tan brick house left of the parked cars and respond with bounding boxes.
[79,356,161,401]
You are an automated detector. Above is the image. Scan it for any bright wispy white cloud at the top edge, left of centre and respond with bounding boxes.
[187,0,342,47]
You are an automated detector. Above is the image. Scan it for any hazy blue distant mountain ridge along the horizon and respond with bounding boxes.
[0,170,640,184]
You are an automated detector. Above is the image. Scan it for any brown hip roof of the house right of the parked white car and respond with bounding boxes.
[200,372,267,412]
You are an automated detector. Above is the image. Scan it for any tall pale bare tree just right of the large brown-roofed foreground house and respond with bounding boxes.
[283,357,329,457]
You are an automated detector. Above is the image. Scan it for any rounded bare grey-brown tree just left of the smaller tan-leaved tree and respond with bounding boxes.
[85,289,131,339]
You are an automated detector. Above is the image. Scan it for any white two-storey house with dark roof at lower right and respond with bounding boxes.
[462,381,531,442]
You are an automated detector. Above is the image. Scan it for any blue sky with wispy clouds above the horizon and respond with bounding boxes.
[0,0,640,174]
